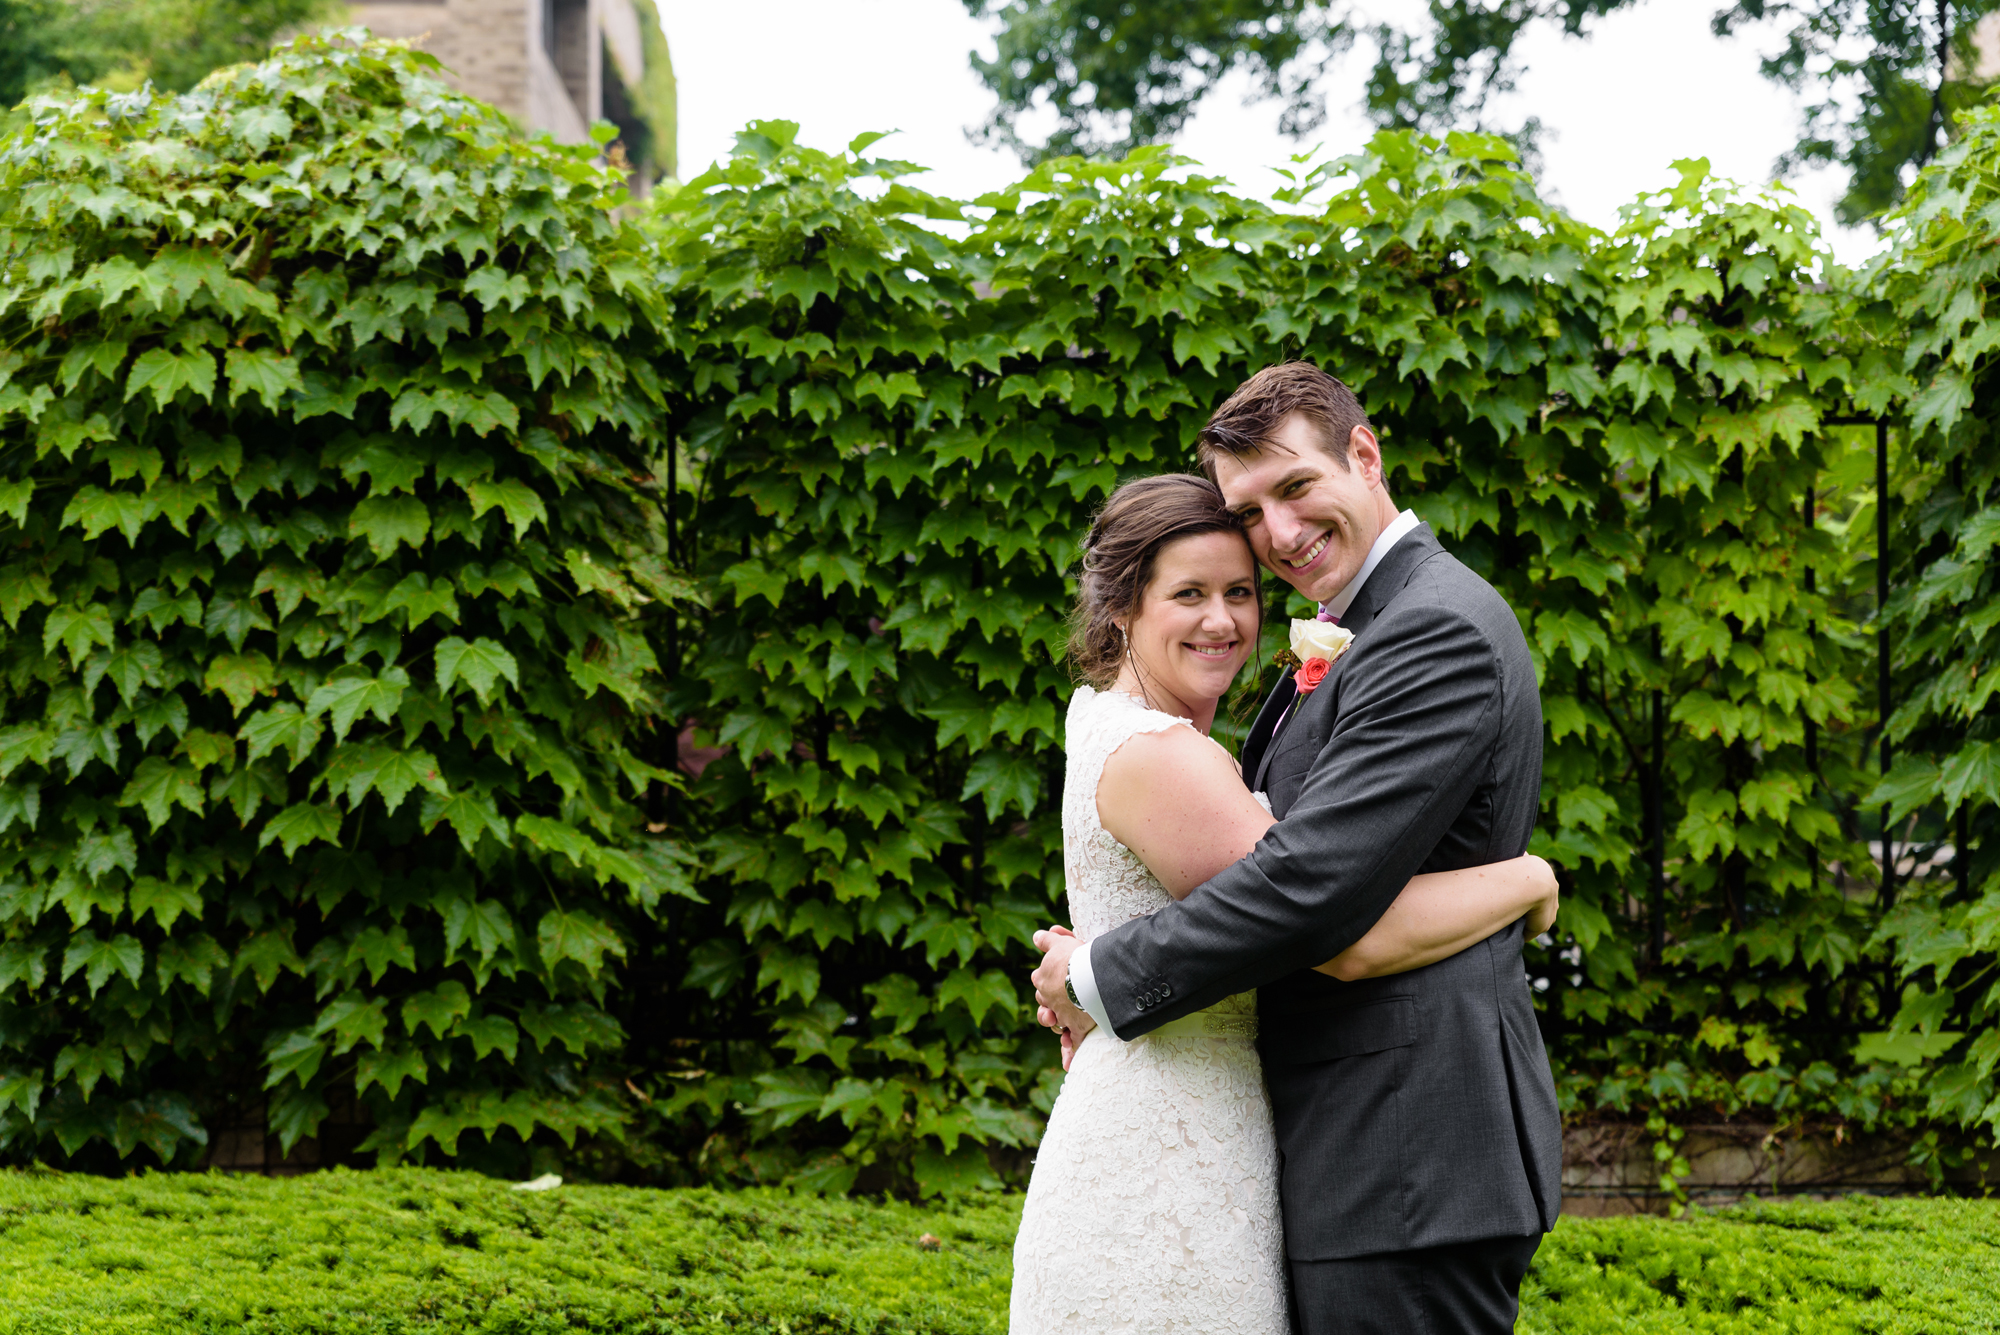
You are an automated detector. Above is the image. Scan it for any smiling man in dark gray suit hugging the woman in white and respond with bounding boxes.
[1034,362,1562,1335]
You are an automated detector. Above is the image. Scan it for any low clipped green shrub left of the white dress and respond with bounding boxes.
[0,1167,1020,1335]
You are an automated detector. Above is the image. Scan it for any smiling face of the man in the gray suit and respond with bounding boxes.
[1216,414,1396,604]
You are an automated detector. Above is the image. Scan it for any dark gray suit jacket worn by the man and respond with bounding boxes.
[1090,526,1562,1261]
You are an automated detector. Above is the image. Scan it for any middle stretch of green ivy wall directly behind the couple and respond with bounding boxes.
[648,124,1952,1189]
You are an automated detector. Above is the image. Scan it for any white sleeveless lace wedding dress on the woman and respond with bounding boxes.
[1008,685,1286,1335]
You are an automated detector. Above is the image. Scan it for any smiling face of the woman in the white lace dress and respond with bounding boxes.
[1118,534,1258,729]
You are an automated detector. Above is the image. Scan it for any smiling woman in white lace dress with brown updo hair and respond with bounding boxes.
[1010,476,1556,1335]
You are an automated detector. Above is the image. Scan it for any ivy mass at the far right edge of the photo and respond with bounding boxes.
[1872,91,2000,1129]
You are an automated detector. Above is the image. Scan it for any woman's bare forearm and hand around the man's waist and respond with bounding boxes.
[1318,853,1556,983]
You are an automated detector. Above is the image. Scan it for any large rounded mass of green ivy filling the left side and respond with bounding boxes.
[0,36,688,1161]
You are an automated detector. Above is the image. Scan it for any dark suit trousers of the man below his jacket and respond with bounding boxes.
[1288,1233,1542,1335]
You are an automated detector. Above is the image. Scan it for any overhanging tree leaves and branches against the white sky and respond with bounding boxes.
[966,0,2000,224]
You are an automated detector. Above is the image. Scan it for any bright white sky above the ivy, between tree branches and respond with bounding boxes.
[660,0,1876,264]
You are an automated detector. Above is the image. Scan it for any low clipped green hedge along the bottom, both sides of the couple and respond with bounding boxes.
[0,1169,2000,1335]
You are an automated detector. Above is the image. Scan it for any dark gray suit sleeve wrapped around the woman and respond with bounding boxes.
[1090,604,1504,1039]
